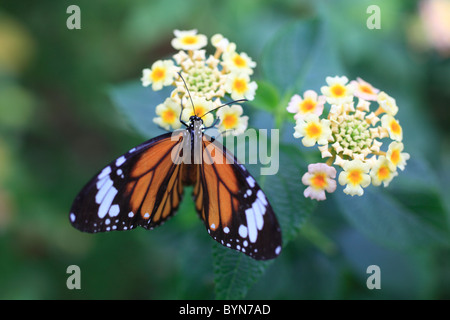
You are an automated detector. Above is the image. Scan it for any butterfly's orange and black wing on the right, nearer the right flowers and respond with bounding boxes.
[193,136,282,260]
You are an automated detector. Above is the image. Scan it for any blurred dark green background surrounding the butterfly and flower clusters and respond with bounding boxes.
[0,0,450,299]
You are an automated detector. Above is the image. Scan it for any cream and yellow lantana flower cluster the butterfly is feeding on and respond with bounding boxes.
[141,30,257,135]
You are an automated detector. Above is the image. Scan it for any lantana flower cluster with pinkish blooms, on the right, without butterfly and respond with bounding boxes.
[287,76,410,200]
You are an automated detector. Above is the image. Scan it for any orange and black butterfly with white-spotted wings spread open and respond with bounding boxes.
[69,87,282,260]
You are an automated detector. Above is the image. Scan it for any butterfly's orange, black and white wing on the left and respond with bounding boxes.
[69,130,187,232]
